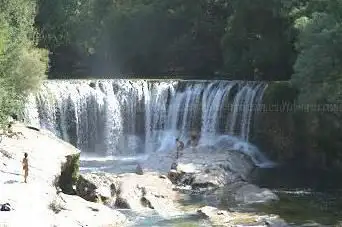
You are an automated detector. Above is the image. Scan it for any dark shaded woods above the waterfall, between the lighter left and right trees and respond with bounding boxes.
[35,0,296,80]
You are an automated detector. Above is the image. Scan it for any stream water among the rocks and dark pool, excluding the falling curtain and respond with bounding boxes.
[81,155,342,227]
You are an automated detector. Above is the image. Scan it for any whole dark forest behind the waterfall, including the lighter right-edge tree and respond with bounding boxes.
[32,0,342,102]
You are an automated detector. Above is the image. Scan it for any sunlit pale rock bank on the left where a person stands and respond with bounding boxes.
[0,124,128,227]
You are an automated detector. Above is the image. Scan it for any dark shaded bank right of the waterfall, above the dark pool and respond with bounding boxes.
[251,82,342,172]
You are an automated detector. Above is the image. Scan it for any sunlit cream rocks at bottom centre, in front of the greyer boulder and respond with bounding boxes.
[77,172,287,227]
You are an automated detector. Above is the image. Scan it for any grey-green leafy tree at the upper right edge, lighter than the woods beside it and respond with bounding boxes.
[292,1,342,103]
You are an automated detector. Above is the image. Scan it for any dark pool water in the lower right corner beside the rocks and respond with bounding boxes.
[251,165,342,226]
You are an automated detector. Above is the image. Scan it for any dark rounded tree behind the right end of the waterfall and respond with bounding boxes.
[222,0,295,80]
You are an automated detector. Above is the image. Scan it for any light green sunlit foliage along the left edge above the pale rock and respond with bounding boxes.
[0,0,48,126]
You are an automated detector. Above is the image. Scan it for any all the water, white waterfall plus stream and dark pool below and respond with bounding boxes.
[23,79,342,227]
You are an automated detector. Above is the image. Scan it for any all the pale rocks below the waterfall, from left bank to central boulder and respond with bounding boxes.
[0,124,286,227]
